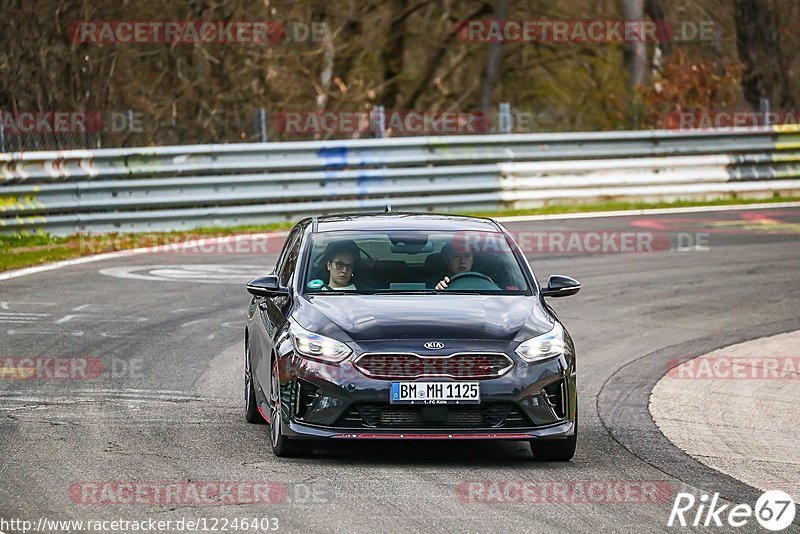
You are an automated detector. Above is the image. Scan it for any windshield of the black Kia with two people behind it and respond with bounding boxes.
[303,231,529,295]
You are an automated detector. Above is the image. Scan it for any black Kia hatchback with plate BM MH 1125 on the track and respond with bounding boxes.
[245,213,580,461]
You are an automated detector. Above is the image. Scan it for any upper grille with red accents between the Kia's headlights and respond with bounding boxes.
[355,352,514,379]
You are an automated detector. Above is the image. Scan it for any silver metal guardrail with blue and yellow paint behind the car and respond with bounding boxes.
[0,125,800,235]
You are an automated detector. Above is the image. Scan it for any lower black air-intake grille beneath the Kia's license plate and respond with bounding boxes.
[336,402,533,429]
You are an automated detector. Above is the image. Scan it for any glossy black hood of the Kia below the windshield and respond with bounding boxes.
[296,294,553,341]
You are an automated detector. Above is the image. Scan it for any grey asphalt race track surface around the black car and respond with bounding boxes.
[0,208,800,532]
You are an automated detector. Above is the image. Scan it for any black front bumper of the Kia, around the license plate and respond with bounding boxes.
[279,344,577,440]
